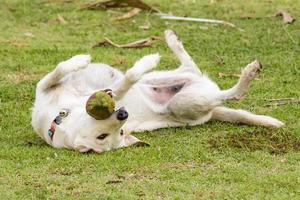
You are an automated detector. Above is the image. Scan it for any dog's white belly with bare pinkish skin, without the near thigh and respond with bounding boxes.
[117,72,192,121]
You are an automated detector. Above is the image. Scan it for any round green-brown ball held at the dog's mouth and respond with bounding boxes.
[86,91,115,120]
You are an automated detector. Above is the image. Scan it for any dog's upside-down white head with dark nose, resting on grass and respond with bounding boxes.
[58,91,148,153]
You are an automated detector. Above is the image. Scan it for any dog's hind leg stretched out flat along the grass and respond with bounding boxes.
[211,106,284,128]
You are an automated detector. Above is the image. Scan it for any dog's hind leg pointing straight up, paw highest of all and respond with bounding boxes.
[165,30,202,75]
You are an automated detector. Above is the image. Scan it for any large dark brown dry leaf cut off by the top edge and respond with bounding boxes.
[81,0,159,12]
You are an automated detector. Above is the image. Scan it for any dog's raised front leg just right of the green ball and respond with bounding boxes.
[111,53,160,100]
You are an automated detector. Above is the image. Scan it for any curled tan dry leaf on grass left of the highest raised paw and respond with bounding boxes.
[92,36,163,48]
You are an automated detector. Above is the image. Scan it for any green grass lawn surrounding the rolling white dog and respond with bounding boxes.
[0,0,300,199]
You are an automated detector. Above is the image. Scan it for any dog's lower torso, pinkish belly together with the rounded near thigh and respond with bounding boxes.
[116,71,220,122]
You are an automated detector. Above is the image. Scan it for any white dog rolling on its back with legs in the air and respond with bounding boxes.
[32,30,283,152]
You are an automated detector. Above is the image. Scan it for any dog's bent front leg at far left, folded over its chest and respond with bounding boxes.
[37,55,91,91]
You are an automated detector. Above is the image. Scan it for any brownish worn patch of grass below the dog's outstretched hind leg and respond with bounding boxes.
[209,130,300,154]
